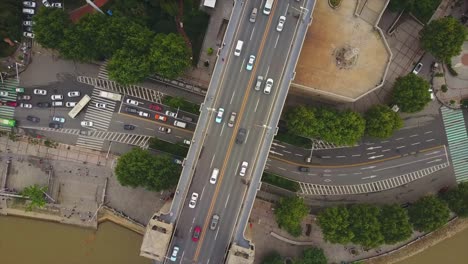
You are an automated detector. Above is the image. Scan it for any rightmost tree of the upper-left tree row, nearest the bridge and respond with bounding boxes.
[149,33,190,79]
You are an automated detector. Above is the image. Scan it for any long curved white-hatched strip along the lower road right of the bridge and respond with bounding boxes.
[299,163,449,195]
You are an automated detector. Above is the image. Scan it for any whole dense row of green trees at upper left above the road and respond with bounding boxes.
[34,8,191,84]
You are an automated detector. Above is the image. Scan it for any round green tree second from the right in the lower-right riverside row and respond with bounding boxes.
[408,195,450,232]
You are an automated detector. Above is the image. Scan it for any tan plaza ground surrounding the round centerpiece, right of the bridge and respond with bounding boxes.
[292,1,390,98]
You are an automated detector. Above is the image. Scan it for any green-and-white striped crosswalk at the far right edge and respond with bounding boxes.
[441,106,468,182]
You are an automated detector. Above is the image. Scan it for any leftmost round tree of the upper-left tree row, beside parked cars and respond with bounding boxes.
[33,7,71,49]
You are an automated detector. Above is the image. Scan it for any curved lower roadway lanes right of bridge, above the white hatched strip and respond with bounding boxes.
[266,146,448,185]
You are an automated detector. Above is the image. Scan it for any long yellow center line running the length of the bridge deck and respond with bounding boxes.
[193,1,276,262]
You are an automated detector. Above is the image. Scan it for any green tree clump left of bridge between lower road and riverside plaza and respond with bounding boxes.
[115,148,181,191]
